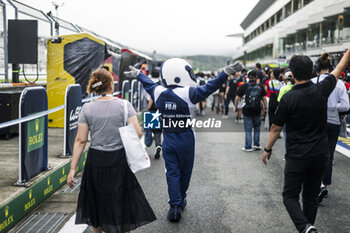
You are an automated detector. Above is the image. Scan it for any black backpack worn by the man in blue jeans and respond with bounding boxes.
[243,84,262,111]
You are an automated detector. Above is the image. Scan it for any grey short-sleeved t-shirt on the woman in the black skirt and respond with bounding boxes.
[78,98,136,151]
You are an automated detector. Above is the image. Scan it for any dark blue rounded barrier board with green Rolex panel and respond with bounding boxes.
[18,87,48,184]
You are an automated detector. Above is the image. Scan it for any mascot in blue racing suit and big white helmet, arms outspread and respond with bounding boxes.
[126,58,243,222]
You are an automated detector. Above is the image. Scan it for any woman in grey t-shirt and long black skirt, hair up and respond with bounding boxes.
[67,69,156,233]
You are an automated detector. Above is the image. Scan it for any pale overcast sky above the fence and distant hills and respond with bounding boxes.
[19,0,258,56]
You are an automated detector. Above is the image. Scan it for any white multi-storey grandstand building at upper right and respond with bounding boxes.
[234,0,350,66]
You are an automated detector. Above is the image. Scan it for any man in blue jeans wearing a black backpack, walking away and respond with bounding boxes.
[235,70,267,152]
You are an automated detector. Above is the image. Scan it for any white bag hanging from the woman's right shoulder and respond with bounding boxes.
[119,100,151,173]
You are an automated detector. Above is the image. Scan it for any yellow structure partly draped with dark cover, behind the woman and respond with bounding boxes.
[47,33,105,128]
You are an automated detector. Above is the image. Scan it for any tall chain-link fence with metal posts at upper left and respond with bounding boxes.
[0,0,123,83]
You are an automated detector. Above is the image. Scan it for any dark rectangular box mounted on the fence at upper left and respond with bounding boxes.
[8,20,38,64]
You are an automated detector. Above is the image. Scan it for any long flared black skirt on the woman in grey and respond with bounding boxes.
[75,148,156,233]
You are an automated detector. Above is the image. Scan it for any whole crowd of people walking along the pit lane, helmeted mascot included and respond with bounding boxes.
[67,47,350,233]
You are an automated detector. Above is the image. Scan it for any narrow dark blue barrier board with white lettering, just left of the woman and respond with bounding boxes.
[63,84,82,157]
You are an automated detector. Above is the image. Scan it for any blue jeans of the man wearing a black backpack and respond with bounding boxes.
[243,115,261,149]
